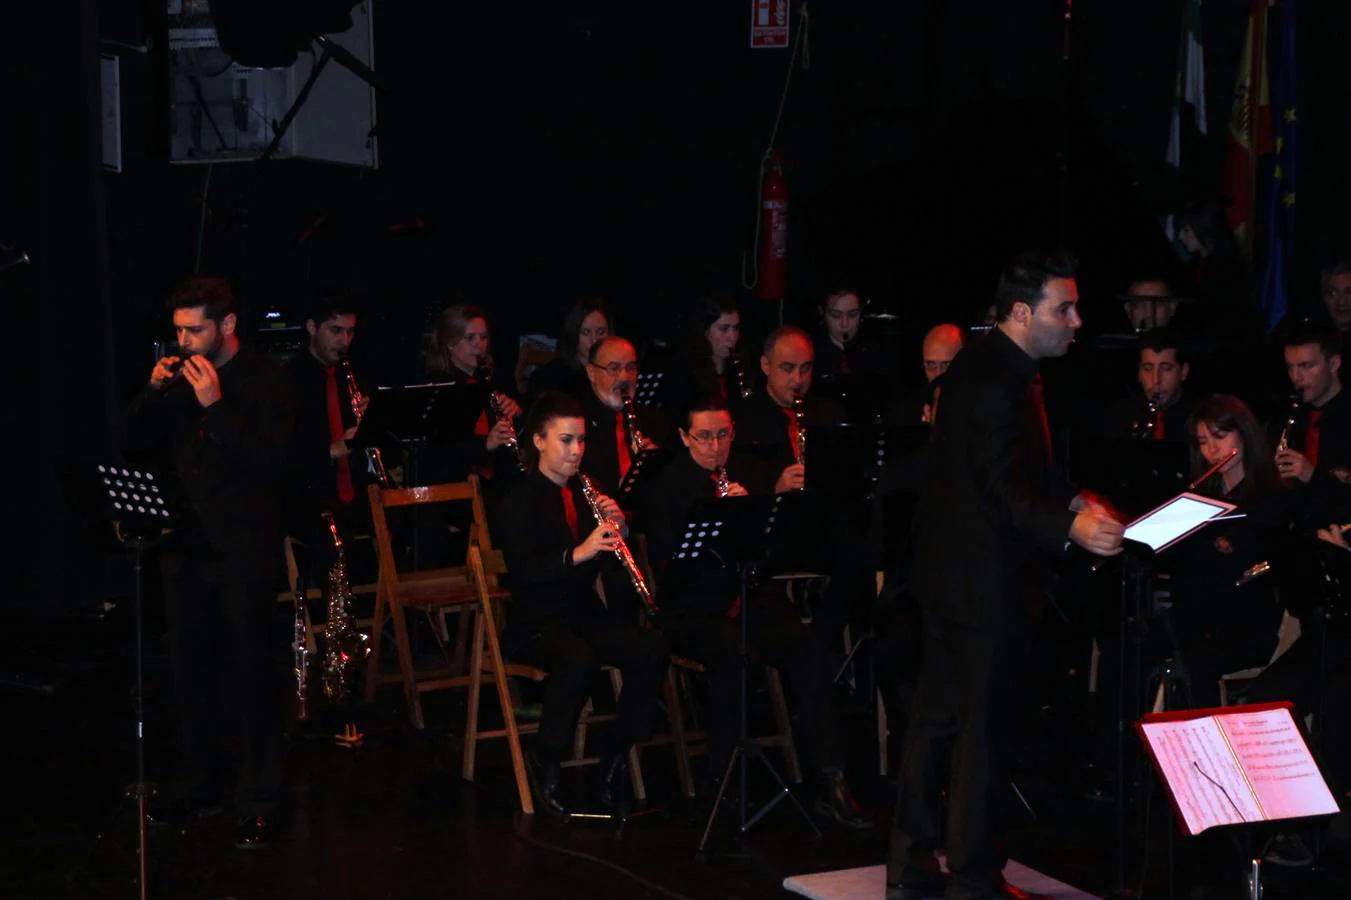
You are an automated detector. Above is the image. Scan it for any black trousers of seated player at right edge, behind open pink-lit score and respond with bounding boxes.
[1243,627,1351,804]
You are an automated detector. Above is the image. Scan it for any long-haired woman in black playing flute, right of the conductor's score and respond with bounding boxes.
[1165,393,1292,707]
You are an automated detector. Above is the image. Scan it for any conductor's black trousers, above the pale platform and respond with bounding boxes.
[886,611,1012,900]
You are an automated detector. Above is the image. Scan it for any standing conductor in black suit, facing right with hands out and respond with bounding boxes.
[888,257,1123,900]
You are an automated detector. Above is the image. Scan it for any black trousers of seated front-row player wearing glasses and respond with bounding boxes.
[662,593,844,774]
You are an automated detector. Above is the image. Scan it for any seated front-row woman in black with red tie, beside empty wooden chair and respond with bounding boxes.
[497,392,670,816]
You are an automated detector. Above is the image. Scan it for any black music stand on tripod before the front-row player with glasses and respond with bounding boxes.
[686,495,821,858]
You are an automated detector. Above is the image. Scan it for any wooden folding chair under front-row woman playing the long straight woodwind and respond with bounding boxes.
[461,543,647,815]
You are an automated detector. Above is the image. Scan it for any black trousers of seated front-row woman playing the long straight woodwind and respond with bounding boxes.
[511,612,670,761]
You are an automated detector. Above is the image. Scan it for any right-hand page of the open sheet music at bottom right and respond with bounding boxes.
[1216,707,1337,819]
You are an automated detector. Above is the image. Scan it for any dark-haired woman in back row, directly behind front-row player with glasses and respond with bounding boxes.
[663,292,755,419]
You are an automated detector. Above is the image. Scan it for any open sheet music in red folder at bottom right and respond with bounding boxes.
[1135,703,1337,834]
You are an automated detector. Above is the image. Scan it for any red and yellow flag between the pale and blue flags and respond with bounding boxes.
[1223,0,1271,253]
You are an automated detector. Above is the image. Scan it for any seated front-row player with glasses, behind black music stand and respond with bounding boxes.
[647,397,871,828]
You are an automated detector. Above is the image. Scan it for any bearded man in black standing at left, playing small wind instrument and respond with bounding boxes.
[123,276,293,849]
